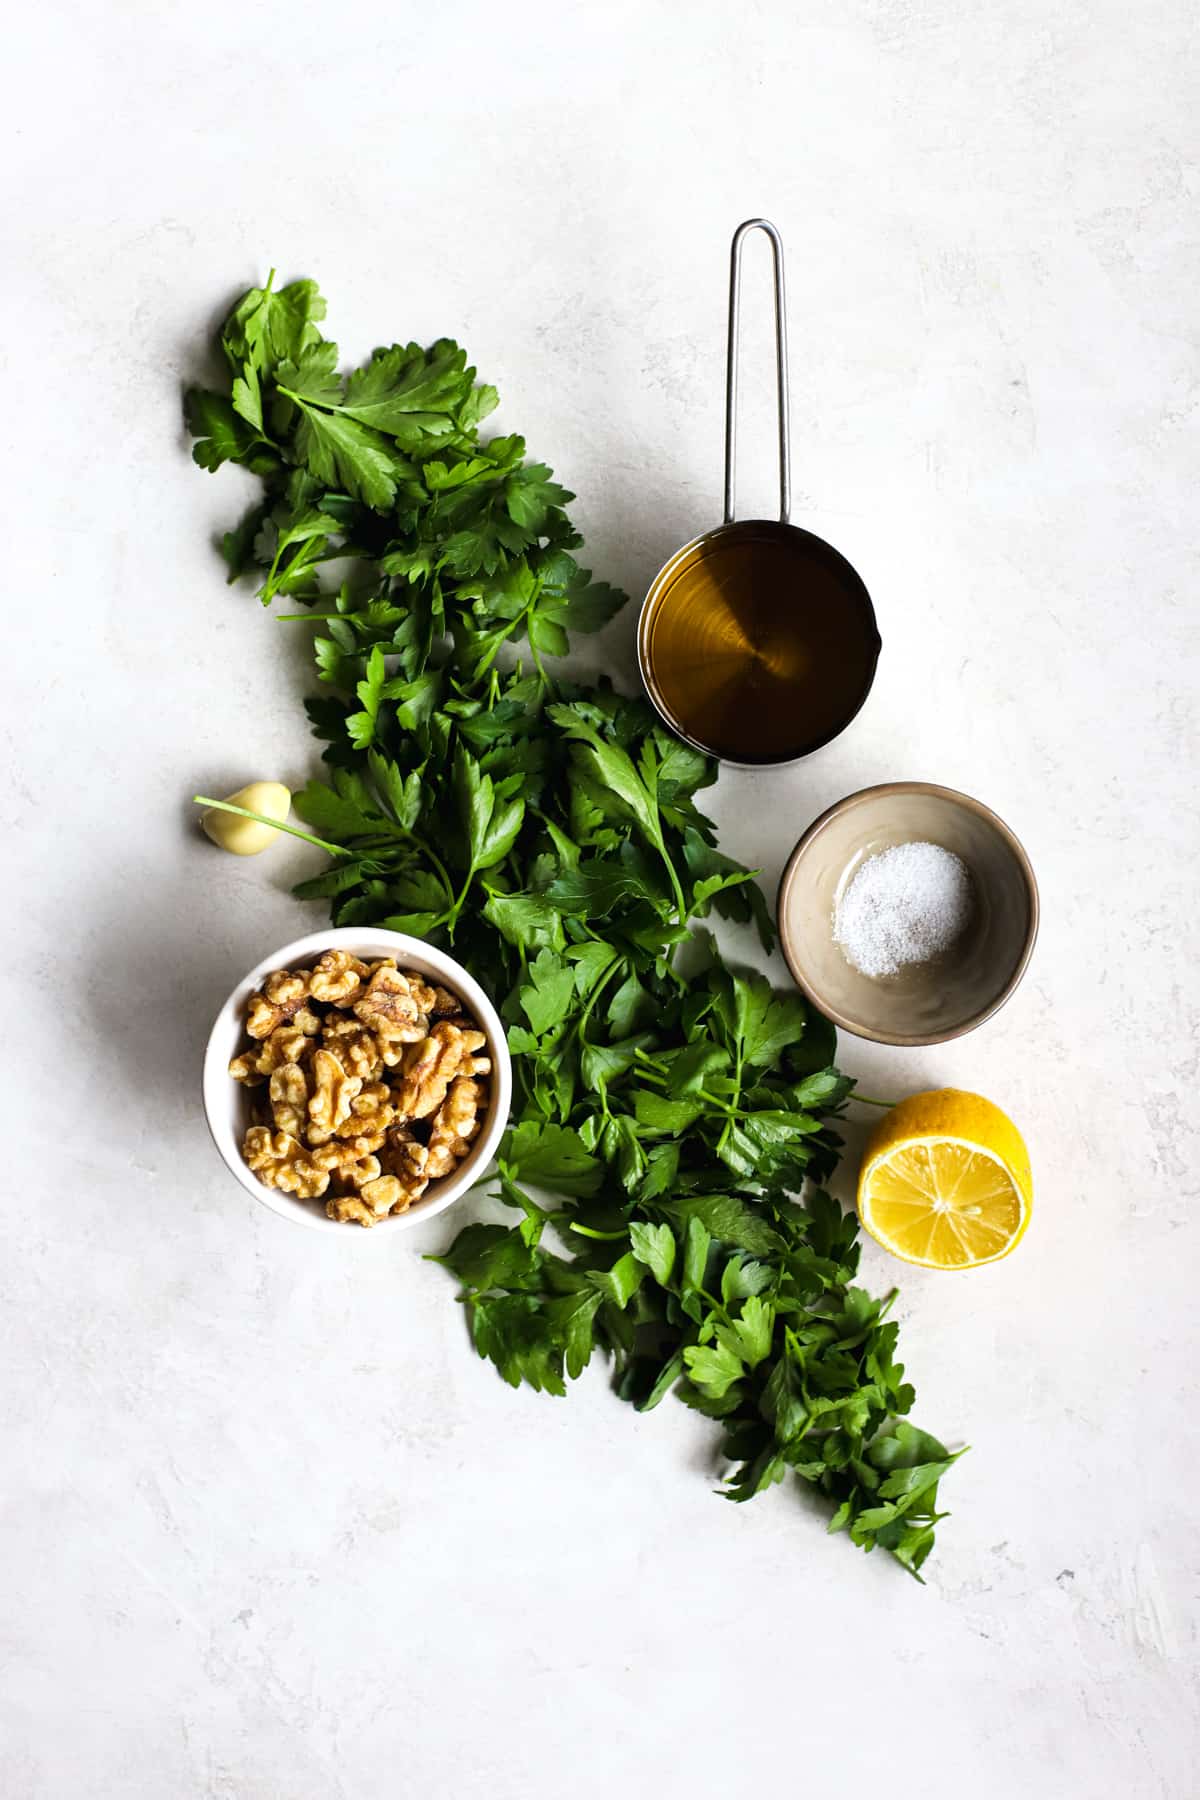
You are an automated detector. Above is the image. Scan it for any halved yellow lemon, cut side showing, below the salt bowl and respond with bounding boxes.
[858,1087,1033,1269]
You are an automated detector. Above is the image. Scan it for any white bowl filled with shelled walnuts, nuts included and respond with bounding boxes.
[203,925,513,1235]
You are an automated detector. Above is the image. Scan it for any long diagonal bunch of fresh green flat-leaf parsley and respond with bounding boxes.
[187,270,954,1575]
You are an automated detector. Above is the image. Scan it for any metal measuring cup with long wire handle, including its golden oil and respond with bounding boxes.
[637,220,880,769]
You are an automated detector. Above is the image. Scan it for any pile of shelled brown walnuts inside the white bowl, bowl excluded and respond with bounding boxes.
[228,949,491,1226]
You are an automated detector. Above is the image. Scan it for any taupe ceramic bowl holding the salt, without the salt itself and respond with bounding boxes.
[779,781,1038,1044]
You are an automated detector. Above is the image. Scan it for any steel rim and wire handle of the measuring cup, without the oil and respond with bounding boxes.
[637,218,882,769]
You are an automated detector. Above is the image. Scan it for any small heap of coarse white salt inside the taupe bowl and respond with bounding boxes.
[833,844,972,976]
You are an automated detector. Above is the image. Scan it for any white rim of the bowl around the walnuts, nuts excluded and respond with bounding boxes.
[201,925,513,1240]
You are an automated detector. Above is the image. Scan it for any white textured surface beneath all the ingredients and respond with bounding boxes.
[0,0,1200,1800]
